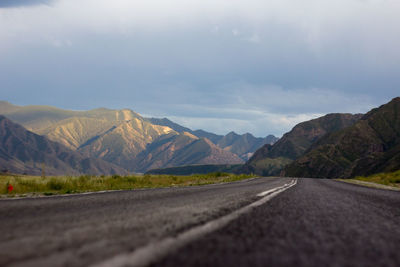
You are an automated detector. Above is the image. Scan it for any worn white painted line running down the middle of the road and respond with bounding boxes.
[92,179,297,267]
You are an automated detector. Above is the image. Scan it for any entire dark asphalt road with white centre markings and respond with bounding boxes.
[0,178,400,267]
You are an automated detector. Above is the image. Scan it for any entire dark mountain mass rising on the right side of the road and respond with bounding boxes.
[244,97,400,178]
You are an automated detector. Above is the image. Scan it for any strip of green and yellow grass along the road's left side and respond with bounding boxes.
[0,172,254,197]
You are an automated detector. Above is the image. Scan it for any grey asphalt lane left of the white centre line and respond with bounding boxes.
[0,178,290,267]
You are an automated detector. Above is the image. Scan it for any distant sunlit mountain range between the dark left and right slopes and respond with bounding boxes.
[0,101,277,175]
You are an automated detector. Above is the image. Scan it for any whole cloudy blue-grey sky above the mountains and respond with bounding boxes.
[0,0,400,136]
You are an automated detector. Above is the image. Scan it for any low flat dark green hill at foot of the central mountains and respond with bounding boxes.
[146,164,242,175]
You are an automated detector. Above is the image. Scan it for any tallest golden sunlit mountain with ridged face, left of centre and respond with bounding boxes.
[0,103,177,171]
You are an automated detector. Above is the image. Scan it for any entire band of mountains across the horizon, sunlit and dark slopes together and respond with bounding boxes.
[0,97,400,178]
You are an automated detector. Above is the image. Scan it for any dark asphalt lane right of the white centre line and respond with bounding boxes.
[153,179,400,267]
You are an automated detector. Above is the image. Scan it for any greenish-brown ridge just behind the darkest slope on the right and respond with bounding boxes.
[242,113,362,176]
